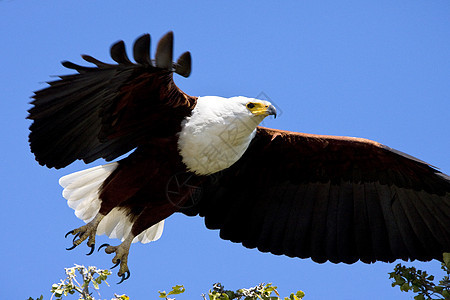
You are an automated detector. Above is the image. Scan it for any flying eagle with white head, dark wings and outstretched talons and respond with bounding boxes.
[28,32,450,281]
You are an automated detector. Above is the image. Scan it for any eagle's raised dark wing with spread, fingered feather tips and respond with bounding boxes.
[28,32,197,168]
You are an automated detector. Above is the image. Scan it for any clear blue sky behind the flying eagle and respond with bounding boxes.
[0,0,450,300]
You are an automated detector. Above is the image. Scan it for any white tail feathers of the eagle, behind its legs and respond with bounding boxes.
[59,162,164,244]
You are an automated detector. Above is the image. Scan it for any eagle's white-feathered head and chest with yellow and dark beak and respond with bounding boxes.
[178,96,276,175]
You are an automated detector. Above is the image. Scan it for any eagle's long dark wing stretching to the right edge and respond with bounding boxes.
[194,128,450,263]
